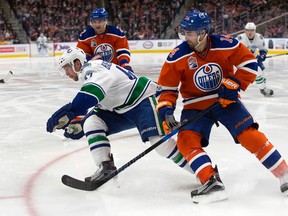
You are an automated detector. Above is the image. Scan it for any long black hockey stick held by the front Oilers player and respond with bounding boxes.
[61,101,220,191]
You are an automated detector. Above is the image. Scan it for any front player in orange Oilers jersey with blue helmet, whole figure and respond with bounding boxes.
[157,10,288,203]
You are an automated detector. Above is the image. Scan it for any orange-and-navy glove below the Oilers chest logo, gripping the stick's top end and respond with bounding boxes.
[218,76,241,108]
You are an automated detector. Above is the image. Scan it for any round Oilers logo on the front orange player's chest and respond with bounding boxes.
[193,63,223,92]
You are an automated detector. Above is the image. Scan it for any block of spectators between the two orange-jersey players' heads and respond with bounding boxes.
[107,0,184,40]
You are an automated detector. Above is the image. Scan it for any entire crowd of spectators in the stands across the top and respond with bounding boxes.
[0,0,288,43]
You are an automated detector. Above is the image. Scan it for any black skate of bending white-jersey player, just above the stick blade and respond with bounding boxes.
[85,156,117,184]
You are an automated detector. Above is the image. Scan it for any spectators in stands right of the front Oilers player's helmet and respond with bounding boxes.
[189,0,288,38]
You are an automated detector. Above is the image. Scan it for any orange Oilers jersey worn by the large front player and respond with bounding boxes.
[158,35,257,110]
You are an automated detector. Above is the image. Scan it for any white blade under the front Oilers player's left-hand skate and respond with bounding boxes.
[192,190,228,204]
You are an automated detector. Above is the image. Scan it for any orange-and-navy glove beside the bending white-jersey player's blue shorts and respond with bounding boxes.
[156,101,181,134]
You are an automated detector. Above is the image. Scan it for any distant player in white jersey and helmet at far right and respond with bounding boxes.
[237,22,274,96]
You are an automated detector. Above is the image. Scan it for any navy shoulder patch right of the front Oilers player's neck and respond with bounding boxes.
[210,35,239,49]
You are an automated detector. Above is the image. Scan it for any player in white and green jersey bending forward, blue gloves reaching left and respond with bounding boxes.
[46,48,193,184]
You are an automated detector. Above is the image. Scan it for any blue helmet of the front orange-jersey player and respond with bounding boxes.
[180,10,211,34]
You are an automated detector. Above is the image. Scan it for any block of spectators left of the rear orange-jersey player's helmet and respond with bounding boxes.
[9,0,97,42]
